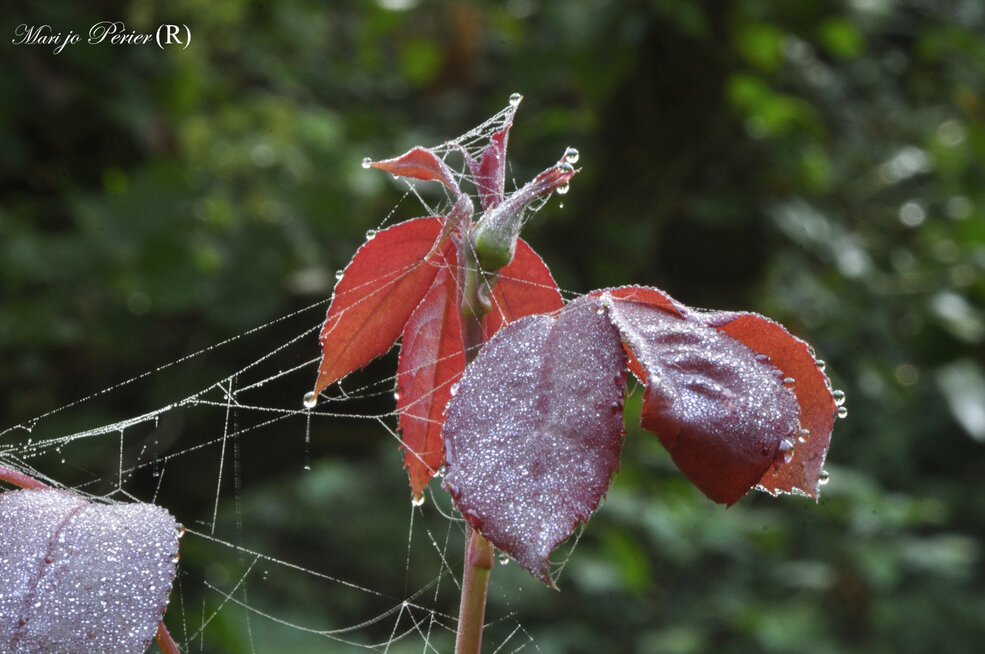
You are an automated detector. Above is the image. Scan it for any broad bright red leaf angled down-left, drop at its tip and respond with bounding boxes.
[315,218,451,393]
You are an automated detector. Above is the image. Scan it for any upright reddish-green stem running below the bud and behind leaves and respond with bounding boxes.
[455,243,495,654]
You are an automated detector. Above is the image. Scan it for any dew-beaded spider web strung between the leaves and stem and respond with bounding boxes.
[0,98,577,652]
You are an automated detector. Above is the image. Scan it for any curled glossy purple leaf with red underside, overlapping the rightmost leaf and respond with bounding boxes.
[602,294,800,504]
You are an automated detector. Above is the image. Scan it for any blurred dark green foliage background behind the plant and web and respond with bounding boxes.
[0,0,985,654]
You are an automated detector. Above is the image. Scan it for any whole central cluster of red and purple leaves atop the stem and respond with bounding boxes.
[315,105,837,584]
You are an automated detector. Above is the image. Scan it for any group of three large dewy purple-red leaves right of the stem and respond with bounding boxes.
[444,286,836,584]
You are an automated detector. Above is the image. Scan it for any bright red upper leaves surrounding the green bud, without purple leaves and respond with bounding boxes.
[314,105,574,498]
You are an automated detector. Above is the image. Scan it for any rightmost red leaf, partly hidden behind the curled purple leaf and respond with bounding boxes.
[701,313,837,498]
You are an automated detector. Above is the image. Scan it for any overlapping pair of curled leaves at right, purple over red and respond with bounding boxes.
[594,286,836,504]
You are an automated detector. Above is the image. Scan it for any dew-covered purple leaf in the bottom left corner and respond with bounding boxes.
[0,490,179,654]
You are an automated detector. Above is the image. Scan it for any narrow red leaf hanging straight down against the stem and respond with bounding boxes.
[397,254,465,498]
